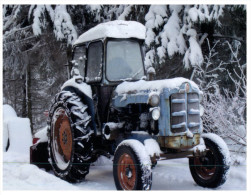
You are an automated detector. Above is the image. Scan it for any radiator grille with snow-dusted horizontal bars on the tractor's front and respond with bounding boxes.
[171,93,200,133]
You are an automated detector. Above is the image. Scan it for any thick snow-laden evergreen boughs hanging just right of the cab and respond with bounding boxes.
[145,5,223,69]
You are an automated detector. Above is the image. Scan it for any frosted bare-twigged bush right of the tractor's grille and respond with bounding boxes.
[194,38,247,153]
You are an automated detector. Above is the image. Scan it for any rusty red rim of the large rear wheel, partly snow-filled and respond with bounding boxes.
[52,108,72,170]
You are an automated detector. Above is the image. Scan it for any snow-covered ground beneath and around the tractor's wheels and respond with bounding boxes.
[3,152,246,190]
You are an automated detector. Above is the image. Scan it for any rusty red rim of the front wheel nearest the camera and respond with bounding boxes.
[118,153,136,190]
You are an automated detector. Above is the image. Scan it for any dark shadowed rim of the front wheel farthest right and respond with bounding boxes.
[194,150,216,180]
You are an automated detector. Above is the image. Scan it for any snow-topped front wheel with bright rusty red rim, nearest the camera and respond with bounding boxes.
[113,140,152,190]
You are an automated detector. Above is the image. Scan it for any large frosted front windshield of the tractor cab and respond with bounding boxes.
[106,40,144,81]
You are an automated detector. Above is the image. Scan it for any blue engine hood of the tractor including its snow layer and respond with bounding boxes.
[113,77,202,107]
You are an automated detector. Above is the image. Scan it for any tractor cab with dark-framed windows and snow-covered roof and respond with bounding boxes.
[71,21,146,86]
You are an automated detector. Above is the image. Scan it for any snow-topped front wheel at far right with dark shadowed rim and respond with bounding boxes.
[189,133,230,188]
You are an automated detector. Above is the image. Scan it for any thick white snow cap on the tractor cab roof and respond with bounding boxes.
[74,20,146,45]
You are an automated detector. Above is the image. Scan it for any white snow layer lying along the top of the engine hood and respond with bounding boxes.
[116,77,199,95]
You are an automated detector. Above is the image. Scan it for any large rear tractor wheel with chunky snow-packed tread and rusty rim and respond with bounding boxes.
[48,91,93,182]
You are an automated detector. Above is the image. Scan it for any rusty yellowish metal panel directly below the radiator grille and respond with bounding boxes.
[157,134,200,149]
